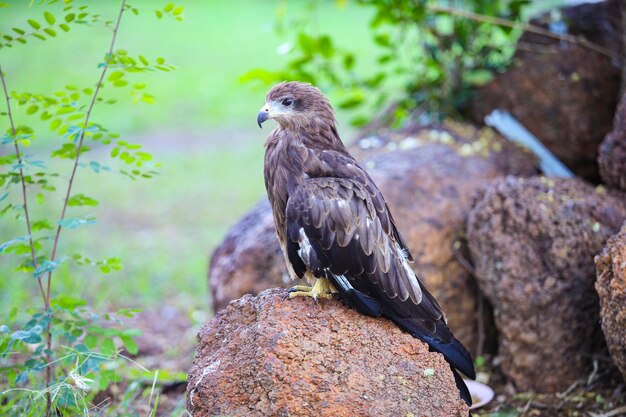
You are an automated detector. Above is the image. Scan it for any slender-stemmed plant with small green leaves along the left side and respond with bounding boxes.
[0,0,183,416]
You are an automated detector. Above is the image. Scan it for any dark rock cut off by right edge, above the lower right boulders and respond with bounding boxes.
[598,92,626,191]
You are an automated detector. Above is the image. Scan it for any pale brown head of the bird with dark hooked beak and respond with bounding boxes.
[257,81,335,129]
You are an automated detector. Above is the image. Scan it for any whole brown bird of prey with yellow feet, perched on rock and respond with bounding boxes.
[257,82,475,404]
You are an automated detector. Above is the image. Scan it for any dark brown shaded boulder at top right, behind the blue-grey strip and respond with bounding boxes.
[471,1,623,177]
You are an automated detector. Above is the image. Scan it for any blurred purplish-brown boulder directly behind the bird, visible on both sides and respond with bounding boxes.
[209,122,536,353]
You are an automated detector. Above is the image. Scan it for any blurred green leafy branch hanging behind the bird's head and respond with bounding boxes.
[241,0,528,127]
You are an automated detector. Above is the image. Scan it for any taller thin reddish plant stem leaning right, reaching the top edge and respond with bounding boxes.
[40,0,126,417]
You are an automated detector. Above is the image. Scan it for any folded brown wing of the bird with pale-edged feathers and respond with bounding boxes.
[286,177,474,376]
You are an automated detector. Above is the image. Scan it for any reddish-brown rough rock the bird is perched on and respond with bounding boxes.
[187,289,468,417]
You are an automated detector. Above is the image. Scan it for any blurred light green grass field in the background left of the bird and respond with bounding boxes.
[0,0,373,312]
